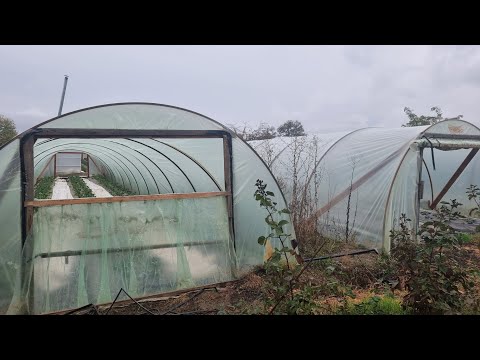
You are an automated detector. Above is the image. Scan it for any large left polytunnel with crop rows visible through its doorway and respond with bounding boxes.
[0,103,295,314]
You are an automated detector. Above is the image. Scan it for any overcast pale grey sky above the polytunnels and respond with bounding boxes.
[0,45,480,132]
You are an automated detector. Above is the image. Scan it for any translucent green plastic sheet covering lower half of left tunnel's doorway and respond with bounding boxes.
[9,197,235,314]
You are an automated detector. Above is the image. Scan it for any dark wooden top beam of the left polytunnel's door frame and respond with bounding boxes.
[34,128,229,139]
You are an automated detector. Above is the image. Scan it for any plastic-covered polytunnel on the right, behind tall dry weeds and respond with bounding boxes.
[250,120,480,252]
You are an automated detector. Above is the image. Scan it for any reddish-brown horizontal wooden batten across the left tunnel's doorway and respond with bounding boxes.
[25,191,230,207]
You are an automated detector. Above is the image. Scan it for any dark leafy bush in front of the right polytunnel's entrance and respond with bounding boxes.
[390,200,474,314]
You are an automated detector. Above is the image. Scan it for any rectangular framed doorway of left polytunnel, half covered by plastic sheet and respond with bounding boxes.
[21,128,235,313]
